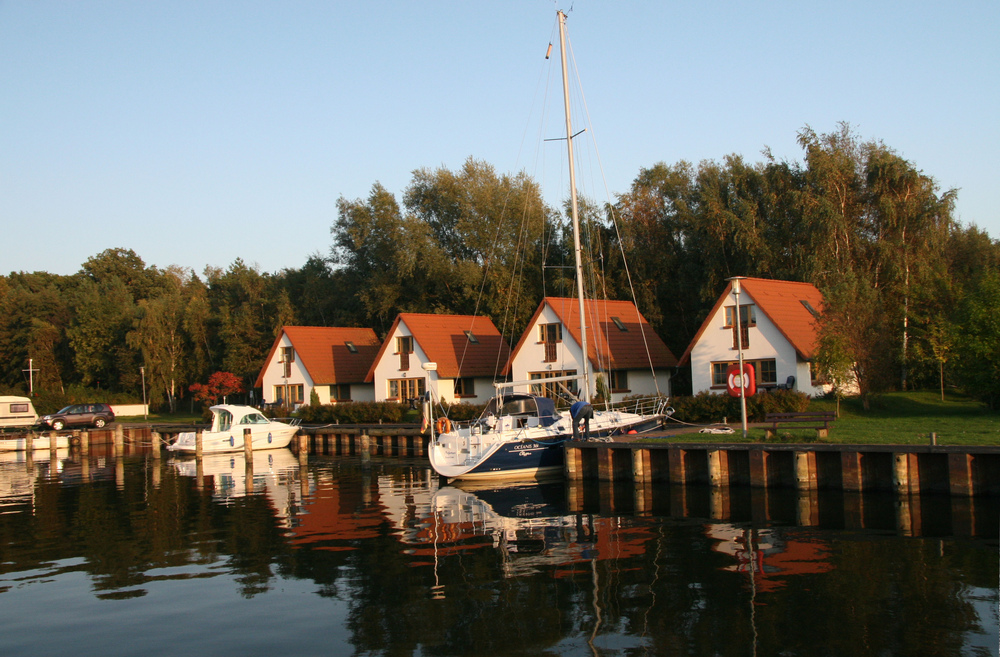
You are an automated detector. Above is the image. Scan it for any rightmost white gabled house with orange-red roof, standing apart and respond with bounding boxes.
[680,278,826,395]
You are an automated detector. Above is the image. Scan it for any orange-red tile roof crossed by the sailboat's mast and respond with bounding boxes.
[505,297,677,372]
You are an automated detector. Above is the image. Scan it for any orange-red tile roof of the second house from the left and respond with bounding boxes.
[365,313,510,381]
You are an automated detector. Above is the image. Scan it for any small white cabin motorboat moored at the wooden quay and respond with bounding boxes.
[167,404,299,454]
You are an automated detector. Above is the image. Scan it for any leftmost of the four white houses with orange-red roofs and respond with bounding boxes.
[254,326,381,406]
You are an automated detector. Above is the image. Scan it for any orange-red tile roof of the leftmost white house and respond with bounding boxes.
[255,326,380,387]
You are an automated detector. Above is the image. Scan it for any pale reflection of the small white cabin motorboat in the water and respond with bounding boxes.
[170,449,299,518]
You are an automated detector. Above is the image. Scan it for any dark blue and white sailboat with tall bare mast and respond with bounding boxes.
[425,11,673,480]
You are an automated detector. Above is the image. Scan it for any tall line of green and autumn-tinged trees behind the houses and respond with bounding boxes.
[0,125,1000,408]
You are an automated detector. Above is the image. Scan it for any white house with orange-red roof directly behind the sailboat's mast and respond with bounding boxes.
[504,297,677,402]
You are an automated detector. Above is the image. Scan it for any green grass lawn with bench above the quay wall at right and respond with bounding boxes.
[643,392,1000,445]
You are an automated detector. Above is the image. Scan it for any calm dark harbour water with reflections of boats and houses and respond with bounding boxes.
[0,450,1000,657]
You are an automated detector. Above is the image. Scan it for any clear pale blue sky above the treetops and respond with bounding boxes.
[0,0,1000,275]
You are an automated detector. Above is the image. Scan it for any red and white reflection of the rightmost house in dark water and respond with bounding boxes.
[705,523,833,592]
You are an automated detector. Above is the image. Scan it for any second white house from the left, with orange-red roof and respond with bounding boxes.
[365,313,510,404]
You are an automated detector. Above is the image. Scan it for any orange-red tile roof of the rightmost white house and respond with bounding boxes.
[680,278,823,364]
